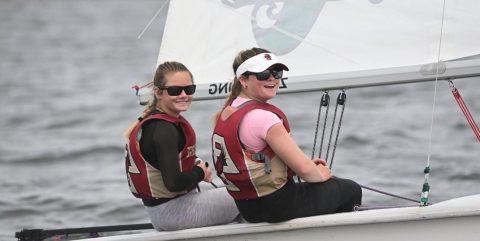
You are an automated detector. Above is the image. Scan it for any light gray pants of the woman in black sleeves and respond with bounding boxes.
[145,187,239,231]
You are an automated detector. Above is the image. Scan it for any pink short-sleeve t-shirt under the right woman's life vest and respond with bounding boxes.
[232,97,282,152]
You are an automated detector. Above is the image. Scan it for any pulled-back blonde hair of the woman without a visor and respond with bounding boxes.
[143,61,193,117]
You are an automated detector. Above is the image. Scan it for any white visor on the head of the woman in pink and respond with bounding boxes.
[235,53,288,78]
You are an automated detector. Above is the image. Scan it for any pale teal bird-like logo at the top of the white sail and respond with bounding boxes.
[222,0,383,55]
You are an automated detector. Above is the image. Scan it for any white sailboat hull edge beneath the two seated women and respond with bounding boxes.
[85,195,480,241]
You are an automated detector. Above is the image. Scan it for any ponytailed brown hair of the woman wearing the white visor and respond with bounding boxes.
[213,48,270,122]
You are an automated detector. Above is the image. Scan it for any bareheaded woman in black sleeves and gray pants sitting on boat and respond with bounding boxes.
[125,62,238,231]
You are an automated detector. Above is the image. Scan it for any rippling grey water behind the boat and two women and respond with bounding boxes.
[0,0,480,240]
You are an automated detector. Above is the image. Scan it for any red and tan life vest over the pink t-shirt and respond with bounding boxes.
[212,101,294,200]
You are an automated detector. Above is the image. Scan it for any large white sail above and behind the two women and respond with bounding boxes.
[154,0,480,99]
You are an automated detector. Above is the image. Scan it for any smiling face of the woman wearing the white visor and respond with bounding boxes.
[239,68,280,102]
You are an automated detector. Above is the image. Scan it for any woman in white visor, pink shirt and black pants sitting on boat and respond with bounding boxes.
[212,48,362,222]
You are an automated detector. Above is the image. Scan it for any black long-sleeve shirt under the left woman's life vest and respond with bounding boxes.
[140,112,205,206]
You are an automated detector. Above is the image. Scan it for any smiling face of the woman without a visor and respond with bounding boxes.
[155,71,193,117]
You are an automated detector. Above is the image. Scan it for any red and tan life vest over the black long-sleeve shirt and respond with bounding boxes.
[125,114,196,199]
